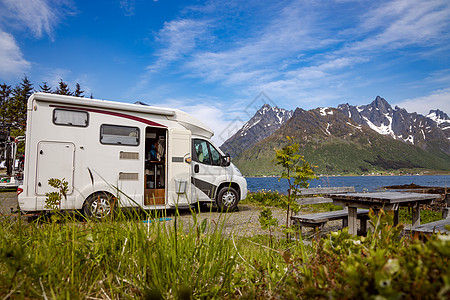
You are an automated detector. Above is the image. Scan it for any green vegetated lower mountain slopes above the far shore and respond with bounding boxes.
[233,128,450,176]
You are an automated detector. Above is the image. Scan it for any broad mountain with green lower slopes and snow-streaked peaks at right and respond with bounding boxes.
[227,97,450,175]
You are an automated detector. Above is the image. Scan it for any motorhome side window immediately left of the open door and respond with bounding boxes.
[100,125,139,146]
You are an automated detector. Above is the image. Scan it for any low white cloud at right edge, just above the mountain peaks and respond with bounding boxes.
[394,88,450,115]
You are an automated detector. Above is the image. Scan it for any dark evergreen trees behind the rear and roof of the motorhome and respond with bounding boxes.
[0,75,84,132]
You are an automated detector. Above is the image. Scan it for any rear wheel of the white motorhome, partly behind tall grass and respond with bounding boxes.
[83,192,115,219]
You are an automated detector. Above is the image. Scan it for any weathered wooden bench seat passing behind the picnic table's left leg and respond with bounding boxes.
[291,209,369,237]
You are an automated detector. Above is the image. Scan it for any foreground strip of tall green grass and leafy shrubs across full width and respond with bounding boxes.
[0,207,450,299]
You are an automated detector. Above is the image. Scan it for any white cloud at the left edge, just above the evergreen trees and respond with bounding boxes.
[0,30,31,77]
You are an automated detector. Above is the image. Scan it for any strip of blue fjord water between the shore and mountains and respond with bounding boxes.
[246,175,450,193]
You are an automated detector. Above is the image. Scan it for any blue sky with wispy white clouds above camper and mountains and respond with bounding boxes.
[0,0,450,144]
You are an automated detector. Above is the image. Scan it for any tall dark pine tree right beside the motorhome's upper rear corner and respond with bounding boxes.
[6,75,34,129]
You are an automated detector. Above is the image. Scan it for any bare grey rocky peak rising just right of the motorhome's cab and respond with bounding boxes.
[220,104,293,157]
